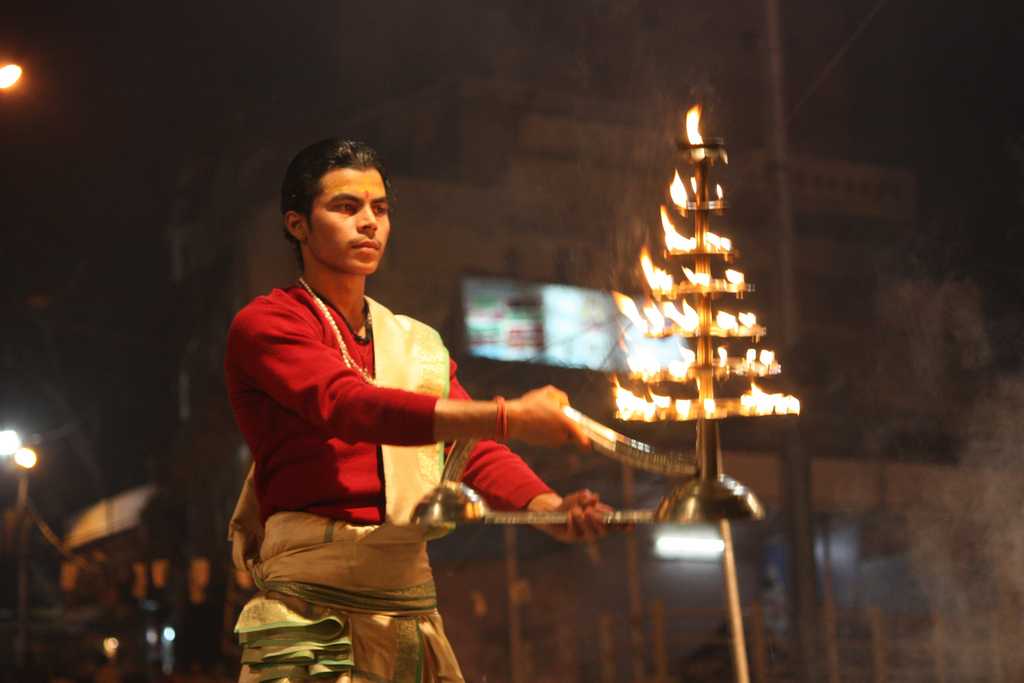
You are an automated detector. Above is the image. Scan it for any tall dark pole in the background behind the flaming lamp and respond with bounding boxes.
[765,0,818,683]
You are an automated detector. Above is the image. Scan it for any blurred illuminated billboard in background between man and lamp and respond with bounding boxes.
[462,276,685,372]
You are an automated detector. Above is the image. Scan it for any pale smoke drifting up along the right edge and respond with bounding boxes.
[880,280,1024,680]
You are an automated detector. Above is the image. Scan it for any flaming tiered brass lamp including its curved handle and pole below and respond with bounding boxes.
[413,106,800,683]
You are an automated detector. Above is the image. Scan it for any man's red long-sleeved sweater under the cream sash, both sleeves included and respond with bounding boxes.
[224,287,550,524]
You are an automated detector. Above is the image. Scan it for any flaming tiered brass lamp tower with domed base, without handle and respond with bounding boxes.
[614,106,800,522]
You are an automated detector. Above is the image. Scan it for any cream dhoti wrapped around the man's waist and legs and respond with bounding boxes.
[236,512,463,683]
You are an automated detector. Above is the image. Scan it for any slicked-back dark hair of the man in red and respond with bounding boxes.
[281,137,391,266]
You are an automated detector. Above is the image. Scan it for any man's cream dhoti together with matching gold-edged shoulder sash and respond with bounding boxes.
[230,300,463,683]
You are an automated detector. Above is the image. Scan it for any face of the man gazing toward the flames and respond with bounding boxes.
[302,168,391,275]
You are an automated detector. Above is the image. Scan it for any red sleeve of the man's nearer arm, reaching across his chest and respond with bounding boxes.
[226,300,437,445]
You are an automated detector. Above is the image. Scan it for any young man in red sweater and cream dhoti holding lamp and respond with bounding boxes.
[225,139,608,683]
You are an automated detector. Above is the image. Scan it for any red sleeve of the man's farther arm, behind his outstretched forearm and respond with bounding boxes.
[449,360,551,510]
